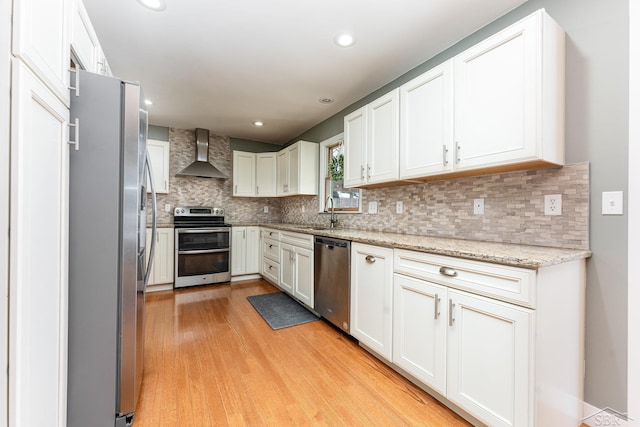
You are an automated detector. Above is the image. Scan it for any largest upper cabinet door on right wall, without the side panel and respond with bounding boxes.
[454,14,541,169]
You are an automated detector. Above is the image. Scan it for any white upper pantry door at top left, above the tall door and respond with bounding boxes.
[13,0,72,107]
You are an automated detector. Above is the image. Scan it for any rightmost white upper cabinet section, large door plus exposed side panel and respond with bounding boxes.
[454,9,565,169]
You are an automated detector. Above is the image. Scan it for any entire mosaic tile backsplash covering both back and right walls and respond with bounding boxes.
[148,128,589,249]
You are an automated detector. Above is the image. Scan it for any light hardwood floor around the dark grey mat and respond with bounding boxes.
[138,280,469,427]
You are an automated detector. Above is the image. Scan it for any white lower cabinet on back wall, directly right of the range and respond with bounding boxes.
[231,227,260,276]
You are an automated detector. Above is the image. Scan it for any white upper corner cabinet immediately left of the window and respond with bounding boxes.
[277,141,319,196]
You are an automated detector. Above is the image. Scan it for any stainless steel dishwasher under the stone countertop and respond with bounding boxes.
[313,236,351,332]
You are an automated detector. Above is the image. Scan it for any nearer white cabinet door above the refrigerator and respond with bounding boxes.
[71,0,100,73]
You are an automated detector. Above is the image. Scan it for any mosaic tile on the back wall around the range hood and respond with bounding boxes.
[149,128,281,224]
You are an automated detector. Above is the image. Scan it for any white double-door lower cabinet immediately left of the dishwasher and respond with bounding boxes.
[279,231,313,308]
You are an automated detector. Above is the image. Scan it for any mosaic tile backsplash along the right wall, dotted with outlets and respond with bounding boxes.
[282,163,589,249]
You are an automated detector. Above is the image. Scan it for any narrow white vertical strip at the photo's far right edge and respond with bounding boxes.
[627,0,640,427]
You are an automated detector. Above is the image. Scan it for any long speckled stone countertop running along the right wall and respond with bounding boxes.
[232,222,591,270]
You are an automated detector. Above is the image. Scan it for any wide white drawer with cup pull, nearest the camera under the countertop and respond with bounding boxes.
[394,249,536,308]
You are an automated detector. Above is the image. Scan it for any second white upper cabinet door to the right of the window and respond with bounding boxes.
[366,89,400,184]
